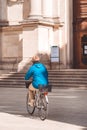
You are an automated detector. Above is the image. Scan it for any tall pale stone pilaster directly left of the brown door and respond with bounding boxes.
[65,0,73,68]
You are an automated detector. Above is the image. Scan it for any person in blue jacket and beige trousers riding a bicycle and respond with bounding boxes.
[25,55,48,106]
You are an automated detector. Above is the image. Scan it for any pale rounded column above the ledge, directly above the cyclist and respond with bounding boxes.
[29,0,42,18]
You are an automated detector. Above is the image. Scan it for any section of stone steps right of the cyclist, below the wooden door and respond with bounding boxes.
[49,69,87,87]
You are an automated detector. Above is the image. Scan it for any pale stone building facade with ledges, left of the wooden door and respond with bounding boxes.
[0,0,79,71]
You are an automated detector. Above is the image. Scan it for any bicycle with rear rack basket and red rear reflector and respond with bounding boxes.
[26,82,50,120]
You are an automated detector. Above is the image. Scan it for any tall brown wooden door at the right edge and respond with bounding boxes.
[73,0,87,68]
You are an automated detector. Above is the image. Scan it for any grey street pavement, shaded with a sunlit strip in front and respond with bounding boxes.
[0,88,87,130]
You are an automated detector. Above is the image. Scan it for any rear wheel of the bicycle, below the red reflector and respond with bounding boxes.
[38,96,48,120]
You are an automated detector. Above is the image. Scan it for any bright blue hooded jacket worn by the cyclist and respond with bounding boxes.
[25,62,48,89]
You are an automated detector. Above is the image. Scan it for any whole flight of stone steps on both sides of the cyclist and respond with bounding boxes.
[0,69,87,88]
